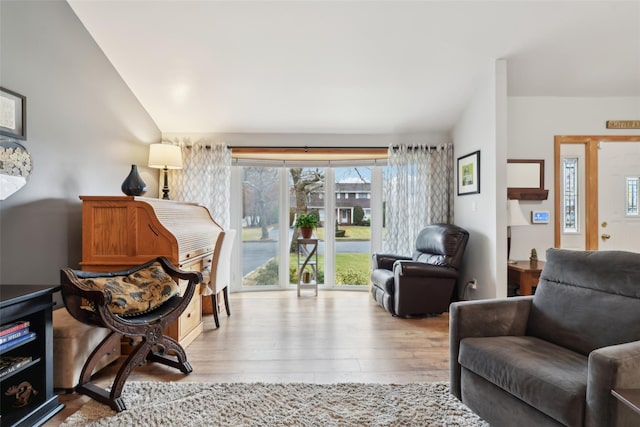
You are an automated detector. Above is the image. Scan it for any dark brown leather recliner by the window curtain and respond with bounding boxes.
[371,224,469,316]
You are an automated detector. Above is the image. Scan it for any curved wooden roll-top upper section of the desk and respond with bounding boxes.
[80,196,223,265]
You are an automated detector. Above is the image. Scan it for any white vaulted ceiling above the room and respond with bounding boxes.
[68,0,640,133]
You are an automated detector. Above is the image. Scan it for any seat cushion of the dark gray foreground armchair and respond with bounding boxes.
[458,336,588,425]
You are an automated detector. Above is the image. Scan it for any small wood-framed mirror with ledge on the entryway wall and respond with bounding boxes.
[507,159,549,200]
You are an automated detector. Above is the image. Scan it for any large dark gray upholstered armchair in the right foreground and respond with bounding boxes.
[450,249,640,427]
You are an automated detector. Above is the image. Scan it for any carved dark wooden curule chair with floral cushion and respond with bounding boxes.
[61,257,202,412]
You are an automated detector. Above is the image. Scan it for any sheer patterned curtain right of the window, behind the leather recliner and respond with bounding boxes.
[384,144,455,255]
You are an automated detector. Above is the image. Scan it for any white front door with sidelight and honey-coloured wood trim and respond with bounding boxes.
[554,135,640,252]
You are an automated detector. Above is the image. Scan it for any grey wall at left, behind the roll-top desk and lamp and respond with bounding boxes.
[0,0,161,284]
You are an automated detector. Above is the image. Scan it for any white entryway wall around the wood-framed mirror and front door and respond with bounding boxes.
[507,97,640,259]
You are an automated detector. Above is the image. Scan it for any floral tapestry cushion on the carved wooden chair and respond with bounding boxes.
[81,262,180,317]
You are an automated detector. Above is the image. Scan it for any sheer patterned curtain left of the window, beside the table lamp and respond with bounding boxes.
[169,138,231,229]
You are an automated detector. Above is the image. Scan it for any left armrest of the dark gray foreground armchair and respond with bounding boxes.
[449,296,533,399]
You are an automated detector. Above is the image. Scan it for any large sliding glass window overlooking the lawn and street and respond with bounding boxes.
[232,165,382,290]
